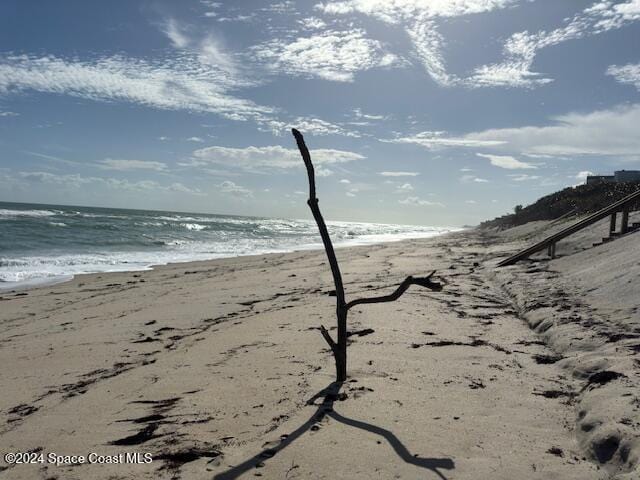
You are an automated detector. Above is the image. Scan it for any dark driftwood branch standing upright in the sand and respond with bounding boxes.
[291,128,442,382]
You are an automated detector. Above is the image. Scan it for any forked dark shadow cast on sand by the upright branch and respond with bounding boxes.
[213,382,455,480]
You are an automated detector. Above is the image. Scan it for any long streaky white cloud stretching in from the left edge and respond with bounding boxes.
[0,55,273,120]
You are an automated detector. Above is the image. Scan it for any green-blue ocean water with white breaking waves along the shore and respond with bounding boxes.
[0,202,457,290]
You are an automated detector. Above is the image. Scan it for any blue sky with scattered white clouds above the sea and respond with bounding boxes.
[0,0,640,226]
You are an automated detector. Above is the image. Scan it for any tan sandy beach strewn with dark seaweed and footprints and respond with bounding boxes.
[0,223,640,480]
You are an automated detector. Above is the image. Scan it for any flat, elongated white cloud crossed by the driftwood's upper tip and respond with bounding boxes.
[188,146,365,172]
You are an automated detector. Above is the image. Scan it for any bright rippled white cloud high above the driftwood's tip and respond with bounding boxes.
[251,29,396,82]
